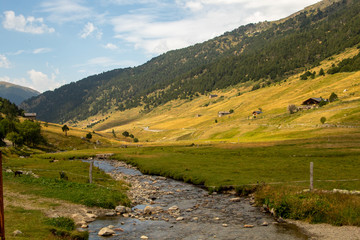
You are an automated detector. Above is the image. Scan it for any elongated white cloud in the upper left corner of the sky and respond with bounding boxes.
[3,11,55,34]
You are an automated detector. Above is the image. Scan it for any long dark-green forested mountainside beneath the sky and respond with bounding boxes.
[21,0,360,123]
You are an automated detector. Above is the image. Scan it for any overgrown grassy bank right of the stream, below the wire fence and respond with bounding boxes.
[255,186,360,226]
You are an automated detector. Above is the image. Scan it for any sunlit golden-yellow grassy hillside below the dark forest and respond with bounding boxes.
[74,48,360,144]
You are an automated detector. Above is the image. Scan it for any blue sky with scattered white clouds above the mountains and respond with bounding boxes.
[0,0,318,92]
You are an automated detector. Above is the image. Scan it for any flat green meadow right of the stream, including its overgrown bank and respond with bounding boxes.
[109,134,360,226]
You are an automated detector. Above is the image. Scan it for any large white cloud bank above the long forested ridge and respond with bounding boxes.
[111,0,317,54]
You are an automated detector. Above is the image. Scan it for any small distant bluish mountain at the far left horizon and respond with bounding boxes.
[0,81,40,105]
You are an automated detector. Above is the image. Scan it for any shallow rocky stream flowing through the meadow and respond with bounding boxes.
[83,160,308,240]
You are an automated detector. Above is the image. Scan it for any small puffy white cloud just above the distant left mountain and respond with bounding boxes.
[27,69,63,92]
